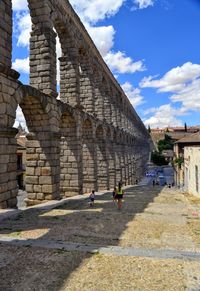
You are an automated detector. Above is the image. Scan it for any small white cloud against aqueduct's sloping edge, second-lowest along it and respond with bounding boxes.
[121,82,144,107]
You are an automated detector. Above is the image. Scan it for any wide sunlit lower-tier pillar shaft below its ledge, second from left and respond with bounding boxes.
[26,132,60,206]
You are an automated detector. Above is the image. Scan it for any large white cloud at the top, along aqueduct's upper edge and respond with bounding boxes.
[71,0,145,74]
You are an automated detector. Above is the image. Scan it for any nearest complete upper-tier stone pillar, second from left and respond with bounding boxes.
[30,26,58,97]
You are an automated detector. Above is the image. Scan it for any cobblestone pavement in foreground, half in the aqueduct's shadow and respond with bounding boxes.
[0,186,200,291]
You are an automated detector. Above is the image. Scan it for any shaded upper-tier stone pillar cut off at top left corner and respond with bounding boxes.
[0,0,12,68]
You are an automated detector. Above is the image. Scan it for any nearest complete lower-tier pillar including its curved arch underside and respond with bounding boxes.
[17,86,60,205]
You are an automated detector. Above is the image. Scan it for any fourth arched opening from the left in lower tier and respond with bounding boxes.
[96,125,109,190]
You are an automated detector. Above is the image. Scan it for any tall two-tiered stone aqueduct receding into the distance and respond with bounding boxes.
[0,0,149,208]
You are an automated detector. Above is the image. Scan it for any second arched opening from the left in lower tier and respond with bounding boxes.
[60,112,81,197]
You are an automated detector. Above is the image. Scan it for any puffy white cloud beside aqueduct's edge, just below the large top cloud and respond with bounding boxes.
[104,51,145,74]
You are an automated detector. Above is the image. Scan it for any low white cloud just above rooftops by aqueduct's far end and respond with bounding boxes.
[143,104,186,128]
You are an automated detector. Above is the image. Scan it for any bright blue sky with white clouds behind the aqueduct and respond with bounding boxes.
[12,0,200,128]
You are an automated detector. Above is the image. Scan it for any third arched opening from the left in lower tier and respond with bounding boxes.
[82,119,98,193]
